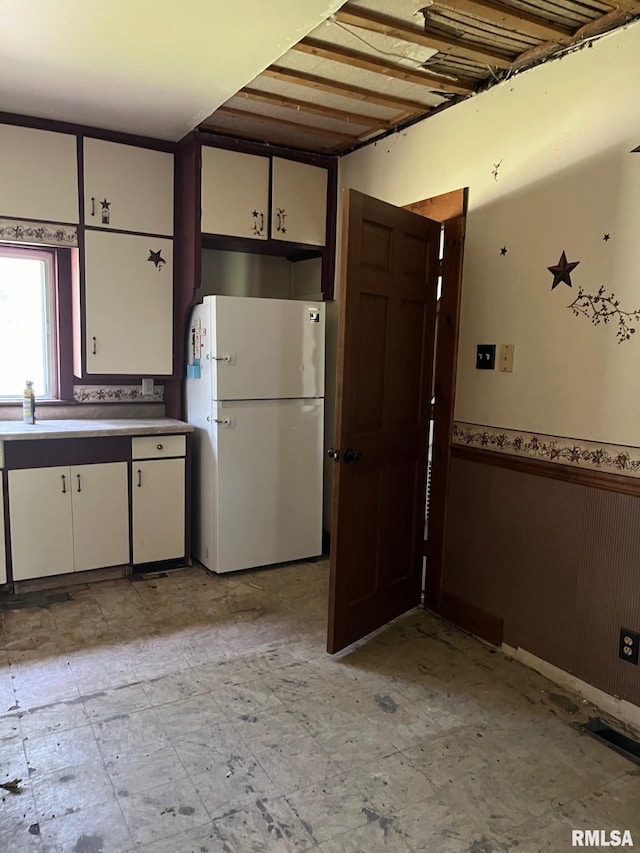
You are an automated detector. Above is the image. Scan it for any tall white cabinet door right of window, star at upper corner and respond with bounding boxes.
[85,231,173,376]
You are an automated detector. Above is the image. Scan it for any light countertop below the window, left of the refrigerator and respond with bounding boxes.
[0,418,194,441]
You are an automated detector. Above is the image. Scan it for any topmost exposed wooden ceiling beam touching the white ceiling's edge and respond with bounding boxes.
[335,4,513,68]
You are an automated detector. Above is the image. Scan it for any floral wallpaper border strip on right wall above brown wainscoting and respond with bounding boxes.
[453,422,640,477]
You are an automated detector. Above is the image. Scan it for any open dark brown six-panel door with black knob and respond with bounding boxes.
[328,190,440,653]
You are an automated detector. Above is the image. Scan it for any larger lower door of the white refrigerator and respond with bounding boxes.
[212,400,324,572]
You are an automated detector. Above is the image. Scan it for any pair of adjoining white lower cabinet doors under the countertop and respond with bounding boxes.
[9,462,129,581]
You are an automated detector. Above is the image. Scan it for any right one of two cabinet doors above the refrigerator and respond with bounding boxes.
[271,157,327,246]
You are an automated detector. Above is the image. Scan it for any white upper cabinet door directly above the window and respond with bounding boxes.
[0,124,79,224]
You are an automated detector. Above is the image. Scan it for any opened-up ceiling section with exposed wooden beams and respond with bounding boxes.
[200,0,640,153]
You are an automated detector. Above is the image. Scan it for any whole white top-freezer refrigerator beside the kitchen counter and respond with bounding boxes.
[186,296,325,572]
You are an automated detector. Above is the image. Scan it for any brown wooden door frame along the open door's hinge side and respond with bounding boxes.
[404,187,469,612]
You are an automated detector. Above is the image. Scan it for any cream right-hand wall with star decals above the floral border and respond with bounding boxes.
[339,23,640,446]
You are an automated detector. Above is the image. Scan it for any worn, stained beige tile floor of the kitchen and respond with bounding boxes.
[0,562,640,853]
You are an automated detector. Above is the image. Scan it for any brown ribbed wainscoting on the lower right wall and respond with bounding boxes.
[443,447,640,705]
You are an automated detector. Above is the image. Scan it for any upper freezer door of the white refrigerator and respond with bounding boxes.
[208,296,325,400]
